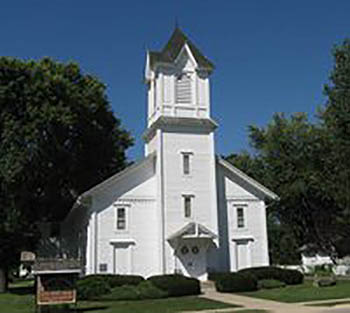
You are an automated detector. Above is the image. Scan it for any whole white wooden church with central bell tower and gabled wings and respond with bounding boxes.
[62,28,276,280]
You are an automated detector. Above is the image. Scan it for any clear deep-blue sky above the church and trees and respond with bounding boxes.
[0,0,350,159]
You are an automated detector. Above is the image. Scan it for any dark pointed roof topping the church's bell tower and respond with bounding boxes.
[149,27,214,71]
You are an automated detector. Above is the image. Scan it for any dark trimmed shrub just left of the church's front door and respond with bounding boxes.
[148,274,201,297]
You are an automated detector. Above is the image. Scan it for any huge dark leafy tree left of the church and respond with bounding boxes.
[0,58,132,292]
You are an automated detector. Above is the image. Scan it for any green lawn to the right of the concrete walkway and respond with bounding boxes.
[241,280,350,302]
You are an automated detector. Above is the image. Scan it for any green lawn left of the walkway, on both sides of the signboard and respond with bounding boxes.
[0,283,238,313]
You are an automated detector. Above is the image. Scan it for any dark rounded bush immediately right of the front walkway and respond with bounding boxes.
[215,273,258,292]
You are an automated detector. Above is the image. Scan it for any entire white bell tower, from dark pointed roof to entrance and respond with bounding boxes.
[144,28,218,275]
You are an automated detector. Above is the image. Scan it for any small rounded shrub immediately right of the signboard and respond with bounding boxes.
[77,277,111,300]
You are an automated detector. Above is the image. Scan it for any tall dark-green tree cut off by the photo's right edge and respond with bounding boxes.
[320,39,350,254]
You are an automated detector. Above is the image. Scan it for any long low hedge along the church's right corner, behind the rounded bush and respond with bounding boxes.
[238,266,304,285]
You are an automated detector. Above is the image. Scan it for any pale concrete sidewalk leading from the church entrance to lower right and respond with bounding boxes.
[201,287,350,313]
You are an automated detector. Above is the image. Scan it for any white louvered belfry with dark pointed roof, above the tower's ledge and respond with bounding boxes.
[145,28,214,127]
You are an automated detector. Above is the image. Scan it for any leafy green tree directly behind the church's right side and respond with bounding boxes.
[226,113,342,262]
